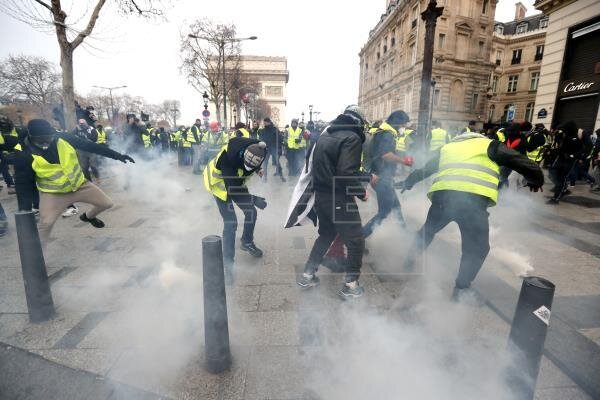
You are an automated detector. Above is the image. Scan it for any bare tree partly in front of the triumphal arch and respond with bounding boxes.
[180,19,241,121]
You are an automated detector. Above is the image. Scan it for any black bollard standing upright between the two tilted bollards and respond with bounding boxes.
[202,235,231,374]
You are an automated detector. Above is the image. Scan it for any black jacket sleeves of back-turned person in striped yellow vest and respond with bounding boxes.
[404,138,544,203]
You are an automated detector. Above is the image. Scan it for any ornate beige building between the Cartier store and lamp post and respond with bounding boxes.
[485,2,548,123]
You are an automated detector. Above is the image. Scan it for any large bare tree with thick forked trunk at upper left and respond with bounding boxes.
[0,0,162,129]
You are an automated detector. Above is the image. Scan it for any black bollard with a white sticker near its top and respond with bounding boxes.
[508,276,554,400]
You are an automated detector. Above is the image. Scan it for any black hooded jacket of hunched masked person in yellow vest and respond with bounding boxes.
[216,137,260,196]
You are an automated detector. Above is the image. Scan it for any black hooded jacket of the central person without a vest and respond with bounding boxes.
[312,114,369,198]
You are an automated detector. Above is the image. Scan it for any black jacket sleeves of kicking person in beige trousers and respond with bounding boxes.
[13,133,121,211]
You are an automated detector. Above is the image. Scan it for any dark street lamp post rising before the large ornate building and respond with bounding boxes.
[418,0,444,148]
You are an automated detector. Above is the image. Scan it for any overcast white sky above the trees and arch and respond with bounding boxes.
[0,0,537,123]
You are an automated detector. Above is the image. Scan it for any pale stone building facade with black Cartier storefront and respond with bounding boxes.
[533,0,600,130]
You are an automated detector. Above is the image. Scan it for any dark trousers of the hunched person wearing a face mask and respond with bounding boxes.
[215,195,257,265]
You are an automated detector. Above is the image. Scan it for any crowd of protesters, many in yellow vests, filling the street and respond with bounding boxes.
[0,105,600,298]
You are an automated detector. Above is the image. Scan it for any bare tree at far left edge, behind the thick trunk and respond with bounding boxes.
[0,56,60,117]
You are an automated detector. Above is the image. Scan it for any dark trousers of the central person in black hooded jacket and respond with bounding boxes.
[304,192,365,282]
